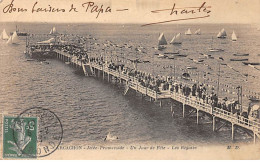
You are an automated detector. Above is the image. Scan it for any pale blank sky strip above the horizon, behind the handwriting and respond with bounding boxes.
[0,0,260,24]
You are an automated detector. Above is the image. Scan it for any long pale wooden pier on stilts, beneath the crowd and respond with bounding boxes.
[26,45,260,143]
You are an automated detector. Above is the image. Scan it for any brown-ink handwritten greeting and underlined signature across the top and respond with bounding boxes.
[3,0,211,26]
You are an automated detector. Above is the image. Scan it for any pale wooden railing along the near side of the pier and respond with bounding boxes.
[53,50,260,134]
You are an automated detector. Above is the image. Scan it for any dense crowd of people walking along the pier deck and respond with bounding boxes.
[39,42,255,118]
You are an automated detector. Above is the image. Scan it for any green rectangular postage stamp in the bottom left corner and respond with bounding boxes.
[3,116,37,158]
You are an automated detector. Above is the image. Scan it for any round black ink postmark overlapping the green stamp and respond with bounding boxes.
[4,107,63,158]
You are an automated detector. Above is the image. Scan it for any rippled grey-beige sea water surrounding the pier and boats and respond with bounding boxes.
[0,24,260,144]
